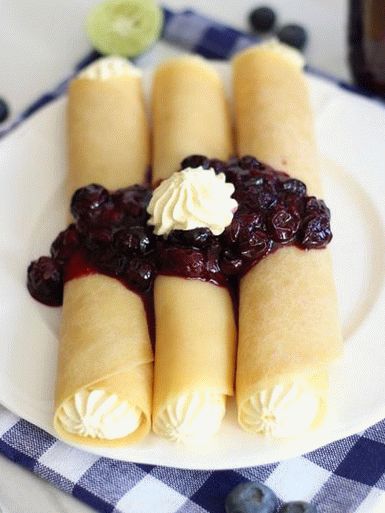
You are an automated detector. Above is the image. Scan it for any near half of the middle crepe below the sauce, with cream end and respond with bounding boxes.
[153,276,236,442]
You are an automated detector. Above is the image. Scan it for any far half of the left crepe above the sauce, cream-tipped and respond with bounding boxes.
[68,57,150,195]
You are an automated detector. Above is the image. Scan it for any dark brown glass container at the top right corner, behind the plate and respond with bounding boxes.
[349,0,385,97]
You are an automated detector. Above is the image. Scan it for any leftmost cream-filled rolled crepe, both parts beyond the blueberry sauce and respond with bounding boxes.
[54,58,153,446]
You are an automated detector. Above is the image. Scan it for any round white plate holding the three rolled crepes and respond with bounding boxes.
[0,64,385,469]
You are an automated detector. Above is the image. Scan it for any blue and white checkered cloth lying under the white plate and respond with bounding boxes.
[0,5,385,513]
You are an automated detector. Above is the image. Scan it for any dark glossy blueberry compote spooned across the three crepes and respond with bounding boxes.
[28,155,332,306]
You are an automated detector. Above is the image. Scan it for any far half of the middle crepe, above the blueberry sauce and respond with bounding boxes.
[152,56,233,183]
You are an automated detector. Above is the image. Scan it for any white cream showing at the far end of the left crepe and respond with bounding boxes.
[77,55,141,80]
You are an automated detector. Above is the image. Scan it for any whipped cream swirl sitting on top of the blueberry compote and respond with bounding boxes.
[147,167,238,236]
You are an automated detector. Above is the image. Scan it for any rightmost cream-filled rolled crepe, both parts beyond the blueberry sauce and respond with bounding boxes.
[233,44,342,437]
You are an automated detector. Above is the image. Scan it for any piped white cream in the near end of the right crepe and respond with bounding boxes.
[239,382,321,438]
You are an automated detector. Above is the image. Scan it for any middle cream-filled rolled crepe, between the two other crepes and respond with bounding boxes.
[153,57,236,442]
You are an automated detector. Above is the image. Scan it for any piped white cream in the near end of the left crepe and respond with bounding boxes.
[58,389,142,440]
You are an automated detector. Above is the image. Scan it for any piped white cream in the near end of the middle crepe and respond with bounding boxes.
[153,392,226,444]
